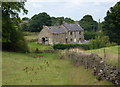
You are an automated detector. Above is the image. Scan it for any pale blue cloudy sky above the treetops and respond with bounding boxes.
[20,0,118,21]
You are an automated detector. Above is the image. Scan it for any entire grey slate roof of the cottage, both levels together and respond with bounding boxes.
[48,24,83,34]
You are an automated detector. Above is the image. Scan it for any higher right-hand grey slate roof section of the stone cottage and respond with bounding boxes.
[63,23,83,31]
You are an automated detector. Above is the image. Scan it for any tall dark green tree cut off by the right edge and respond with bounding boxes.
[103,1,120,44]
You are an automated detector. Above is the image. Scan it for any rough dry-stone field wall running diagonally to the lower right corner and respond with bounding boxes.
[60,52,120,85]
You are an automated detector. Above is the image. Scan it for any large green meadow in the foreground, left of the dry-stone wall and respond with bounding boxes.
[2,52,111,85]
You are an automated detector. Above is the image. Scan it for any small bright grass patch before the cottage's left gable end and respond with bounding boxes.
[28,42,50,50]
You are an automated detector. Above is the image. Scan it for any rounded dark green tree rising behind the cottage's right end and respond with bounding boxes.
[79,15,98,32]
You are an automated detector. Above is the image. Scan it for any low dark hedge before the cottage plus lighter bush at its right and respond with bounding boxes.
[53,33,116,50]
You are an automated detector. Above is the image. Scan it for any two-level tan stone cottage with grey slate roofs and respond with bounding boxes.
[38,23,84,44]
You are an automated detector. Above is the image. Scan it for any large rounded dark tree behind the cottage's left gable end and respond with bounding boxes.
[29,12,52,32]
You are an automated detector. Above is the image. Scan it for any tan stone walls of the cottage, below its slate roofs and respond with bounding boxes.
[38,26,84,45]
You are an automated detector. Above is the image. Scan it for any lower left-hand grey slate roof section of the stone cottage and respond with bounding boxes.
[48,26,66,33]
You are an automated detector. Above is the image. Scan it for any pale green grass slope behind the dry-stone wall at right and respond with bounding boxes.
[85,46,120,66]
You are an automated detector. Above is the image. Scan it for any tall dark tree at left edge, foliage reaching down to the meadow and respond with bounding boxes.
[2,2,28,52]
